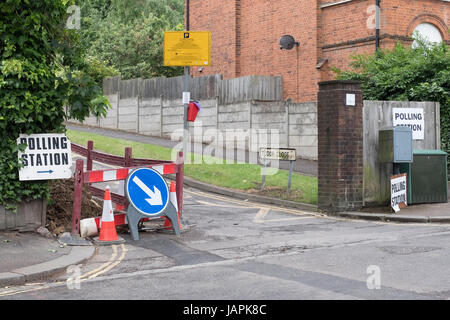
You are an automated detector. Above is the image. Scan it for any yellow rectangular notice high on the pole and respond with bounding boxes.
[164,31,211,67]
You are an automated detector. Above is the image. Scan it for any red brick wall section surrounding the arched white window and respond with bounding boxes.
[322,0,450,80]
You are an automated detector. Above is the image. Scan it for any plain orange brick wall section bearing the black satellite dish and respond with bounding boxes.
[190,0,320,101]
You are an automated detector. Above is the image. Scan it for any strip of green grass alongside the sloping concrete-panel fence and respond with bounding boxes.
[67,130,317,204]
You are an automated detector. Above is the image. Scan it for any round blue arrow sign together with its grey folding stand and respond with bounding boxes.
[125,168,180,240]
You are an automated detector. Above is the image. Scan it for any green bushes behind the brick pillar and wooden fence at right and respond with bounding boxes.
[334,39,450,164]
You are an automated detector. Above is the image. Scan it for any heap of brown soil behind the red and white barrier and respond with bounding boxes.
[46,178,103,235]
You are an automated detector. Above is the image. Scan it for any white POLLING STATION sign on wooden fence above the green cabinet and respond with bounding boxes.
[392,108,425,140]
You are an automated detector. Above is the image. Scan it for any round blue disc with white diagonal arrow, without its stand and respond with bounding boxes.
[125,168,169,216]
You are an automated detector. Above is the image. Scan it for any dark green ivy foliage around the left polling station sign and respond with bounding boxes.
[0,0,109,209]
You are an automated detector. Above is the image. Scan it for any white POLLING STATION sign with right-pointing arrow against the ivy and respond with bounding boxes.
[17,133,72,181]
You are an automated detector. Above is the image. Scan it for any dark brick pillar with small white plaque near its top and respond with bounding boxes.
[317,80,363,212]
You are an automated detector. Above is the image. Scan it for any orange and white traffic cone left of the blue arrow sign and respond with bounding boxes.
[94,186,125,244]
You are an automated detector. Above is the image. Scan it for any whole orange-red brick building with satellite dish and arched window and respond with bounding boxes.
[189,0,450,102]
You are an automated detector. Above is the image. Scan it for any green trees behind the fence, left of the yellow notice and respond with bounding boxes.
[78,0,184,79]
